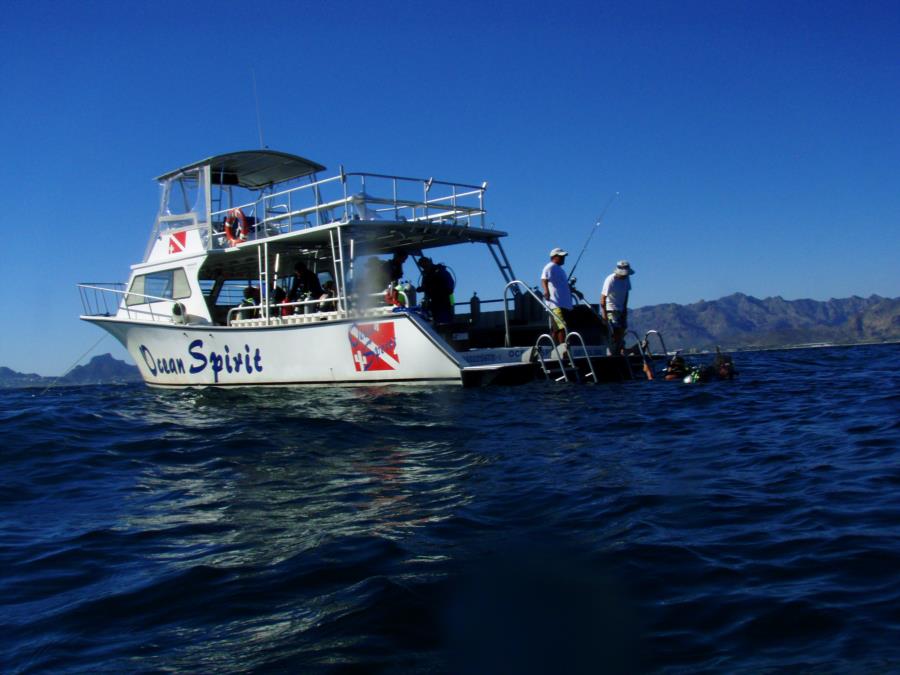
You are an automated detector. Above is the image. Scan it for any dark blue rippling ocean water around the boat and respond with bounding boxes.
[0,345,900,673]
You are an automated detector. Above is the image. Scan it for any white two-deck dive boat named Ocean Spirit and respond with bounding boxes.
[79,150,665,387]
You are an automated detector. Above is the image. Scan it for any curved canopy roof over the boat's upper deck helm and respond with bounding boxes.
[156,150,325,190]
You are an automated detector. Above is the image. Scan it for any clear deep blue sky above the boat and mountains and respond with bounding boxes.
[0,0,900,374]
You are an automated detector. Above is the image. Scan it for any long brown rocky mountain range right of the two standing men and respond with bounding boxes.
[629,293,900,350]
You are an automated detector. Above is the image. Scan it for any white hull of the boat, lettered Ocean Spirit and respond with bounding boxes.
[83,314,466,387]
